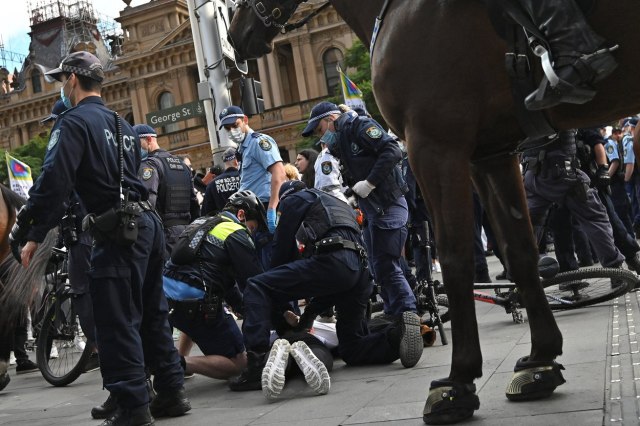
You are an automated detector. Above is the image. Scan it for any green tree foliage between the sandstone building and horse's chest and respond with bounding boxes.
[344,40,387,128]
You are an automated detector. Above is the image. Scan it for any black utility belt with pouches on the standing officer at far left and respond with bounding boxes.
[82,201,153,247]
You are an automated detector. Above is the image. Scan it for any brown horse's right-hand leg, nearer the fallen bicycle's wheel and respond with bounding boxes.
[472,156,564,400]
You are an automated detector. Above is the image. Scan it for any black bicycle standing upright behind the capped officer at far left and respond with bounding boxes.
[34,248,93,386]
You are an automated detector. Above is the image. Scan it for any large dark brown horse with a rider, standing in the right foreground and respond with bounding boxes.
[230,0,640,423]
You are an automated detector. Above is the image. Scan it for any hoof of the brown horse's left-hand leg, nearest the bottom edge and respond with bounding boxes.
[422,379,480,425]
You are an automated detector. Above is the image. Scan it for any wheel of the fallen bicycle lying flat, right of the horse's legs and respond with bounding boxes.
[542,268,638,311]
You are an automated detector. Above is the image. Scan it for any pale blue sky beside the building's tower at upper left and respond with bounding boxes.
[0,0,147,71]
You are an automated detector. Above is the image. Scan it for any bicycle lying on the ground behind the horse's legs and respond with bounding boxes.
[436,268,640,323]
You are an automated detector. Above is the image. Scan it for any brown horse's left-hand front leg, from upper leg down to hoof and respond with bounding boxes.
[405,141,482,424]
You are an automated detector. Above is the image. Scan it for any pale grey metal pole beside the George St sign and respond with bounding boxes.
[187,0,232,156]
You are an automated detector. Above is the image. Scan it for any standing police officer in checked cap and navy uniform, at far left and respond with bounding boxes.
[11,51,191,425]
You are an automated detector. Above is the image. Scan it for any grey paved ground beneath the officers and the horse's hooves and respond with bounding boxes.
[0,257,640,426]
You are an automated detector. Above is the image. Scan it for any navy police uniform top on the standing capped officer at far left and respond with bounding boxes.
[27,96,148,242]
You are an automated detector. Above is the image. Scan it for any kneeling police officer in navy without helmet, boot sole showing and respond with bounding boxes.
[229,181,423,391]
